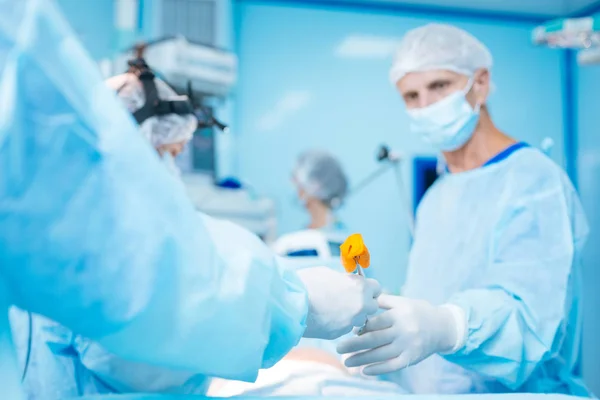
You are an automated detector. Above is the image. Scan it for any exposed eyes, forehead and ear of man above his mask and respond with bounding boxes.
[396,70,489,109]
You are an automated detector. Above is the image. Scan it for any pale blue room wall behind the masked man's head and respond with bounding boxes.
[236,0,564,292]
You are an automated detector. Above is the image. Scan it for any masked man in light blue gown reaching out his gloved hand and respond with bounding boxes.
[338,24,588,396]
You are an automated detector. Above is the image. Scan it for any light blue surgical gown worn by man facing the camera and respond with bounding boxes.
[398,147,588,395]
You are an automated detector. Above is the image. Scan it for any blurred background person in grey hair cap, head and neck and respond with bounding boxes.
[292,150,348,231]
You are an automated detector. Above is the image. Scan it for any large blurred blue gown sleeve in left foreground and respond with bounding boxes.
[0,0,307,380]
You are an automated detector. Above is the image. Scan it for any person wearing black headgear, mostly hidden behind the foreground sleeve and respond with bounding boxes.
[10,70,217,400]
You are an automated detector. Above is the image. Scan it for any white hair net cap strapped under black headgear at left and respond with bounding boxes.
[106,73,198,148]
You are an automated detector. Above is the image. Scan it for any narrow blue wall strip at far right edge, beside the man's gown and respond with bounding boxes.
[573,48,600,395]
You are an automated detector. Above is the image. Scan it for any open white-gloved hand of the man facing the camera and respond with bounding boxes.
[337,294,467,375]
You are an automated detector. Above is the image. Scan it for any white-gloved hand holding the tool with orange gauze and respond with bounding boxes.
[298,267,381,340]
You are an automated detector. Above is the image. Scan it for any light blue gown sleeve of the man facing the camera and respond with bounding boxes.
[446,187,587,389]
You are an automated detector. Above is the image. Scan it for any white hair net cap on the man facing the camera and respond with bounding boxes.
[390,24,493,85]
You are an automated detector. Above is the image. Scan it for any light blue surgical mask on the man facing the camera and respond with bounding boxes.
[407,80,479,151]
